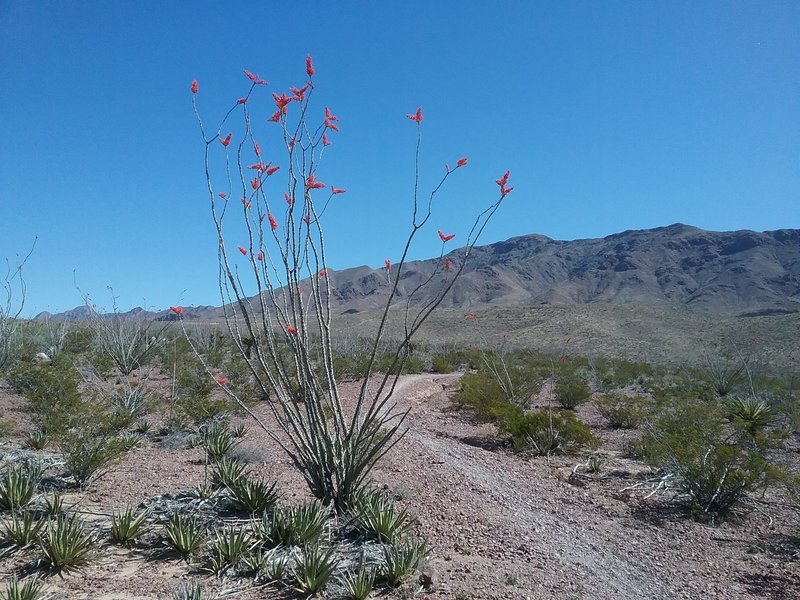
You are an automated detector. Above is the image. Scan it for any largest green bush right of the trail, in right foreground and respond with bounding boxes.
[641,402,781,519]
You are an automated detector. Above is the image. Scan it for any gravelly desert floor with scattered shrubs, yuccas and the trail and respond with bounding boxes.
[0,314,800,599]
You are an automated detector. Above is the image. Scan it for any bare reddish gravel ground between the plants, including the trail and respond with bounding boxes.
[0,374,800,600]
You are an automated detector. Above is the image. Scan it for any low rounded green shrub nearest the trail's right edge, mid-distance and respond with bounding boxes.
[500,408,599,456]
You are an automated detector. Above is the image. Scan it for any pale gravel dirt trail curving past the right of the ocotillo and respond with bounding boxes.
[368,374,800,599]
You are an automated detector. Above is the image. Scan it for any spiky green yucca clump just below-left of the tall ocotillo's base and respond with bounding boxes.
[254,500,328,548]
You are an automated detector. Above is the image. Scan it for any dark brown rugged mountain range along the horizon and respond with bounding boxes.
[36,224,800,319]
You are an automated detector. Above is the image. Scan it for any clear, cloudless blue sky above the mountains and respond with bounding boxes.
[0,0,800,315]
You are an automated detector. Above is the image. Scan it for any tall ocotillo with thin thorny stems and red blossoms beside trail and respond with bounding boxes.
[191,56,511,511]
